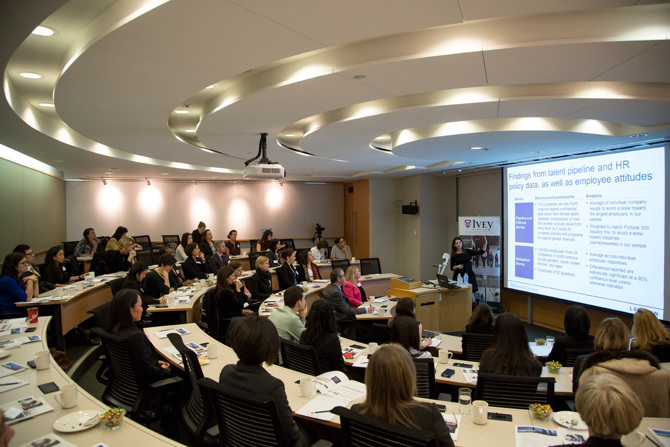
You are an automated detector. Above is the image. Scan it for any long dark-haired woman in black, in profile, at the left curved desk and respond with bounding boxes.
[107,289,171,382]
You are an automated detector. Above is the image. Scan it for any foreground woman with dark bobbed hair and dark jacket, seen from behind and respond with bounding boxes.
[219,315,301,445]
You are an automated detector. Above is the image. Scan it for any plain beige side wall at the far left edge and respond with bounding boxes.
[0,158,65,262]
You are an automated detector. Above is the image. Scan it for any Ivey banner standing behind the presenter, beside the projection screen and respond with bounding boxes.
[458,216,502,302]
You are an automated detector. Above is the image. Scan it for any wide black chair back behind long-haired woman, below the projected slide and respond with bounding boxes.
[475,372,556,409]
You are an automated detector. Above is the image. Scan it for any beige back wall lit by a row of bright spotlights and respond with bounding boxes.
[67,181,344,245]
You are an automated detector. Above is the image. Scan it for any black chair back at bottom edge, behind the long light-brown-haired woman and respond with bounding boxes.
[332,407,438,447]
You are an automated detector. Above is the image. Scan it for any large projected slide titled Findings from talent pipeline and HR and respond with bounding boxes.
[503,148,670,320]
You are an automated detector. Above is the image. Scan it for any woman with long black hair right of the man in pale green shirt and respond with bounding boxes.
[302,300,347,372]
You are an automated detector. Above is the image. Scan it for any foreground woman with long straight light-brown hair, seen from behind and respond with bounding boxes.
[351,343,454,447]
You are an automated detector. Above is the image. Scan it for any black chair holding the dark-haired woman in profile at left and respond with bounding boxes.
[91,328,182,425]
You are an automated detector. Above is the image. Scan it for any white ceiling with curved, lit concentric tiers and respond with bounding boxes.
[0,0,670,181]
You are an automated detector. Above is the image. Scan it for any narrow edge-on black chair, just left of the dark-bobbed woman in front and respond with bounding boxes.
[168,334,219,445]
